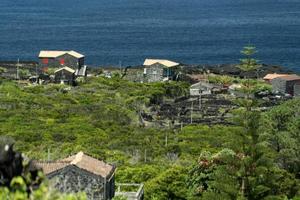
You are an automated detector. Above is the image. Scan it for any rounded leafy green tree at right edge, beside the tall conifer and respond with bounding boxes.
[260,99,300,178]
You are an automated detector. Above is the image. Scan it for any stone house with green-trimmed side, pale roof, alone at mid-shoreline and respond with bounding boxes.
[143,59,179,82]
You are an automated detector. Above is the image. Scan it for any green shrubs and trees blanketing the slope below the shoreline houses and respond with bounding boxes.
[0,48,300,200]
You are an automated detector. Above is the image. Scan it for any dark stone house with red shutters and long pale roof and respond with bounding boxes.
[39,51,84,71]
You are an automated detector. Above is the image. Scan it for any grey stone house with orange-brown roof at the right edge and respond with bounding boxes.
[270,74,300,96]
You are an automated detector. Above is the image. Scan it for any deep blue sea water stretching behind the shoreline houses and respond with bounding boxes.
[0,0,300,70]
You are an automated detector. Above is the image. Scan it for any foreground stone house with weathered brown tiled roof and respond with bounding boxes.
[35,152,116,200]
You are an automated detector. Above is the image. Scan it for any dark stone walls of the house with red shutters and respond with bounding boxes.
[39,53,84,69]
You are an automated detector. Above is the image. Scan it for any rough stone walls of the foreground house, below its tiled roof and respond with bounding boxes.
[47,165,115,200]
